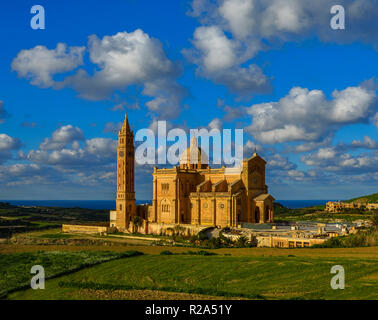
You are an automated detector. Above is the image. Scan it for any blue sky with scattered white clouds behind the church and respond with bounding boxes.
[0,0,378,199]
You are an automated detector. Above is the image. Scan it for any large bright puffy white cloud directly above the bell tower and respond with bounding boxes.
[66,29,178,100]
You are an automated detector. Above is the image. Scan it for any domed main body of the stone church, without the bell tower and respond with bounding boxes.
[148,138,274,227]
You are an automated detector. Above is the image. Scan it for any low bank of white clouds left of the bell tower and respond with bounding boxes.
[0,125,117,188]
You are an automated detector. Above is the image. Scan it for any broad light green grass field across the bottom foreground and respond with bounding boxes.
[8,249,378,299]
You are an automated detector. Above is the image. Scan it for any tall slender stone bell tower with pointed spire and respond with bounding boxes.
[116,115,136,230]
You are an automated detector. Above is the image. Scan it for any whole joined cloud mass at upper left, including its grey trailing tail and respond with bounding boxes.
[12,29,186,118]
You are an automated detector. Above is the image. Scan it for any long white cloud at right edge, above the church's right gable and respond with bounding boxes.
[247,82,376,142]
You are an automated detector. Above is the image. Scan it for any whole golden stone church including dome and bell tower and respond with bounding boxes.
[110,117,274,230]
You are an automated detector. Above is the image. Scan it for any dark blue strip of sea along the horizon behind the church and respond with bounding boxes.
[0,199,335,210]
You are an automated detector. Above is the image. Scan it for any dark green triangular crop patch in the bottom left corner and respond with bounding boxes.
[0,251,142,298]
